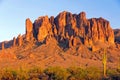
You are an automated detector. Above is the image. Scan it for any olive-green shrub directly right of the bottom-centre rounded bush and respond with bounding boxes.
[67,67,87,80]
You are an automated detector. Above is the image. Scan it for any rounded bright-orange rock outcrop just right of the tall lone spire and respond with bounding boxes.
[34,16,52,42]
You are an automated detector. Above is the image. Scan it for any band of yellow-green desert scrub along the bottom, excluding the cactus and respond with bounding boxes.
[0,67,120,80]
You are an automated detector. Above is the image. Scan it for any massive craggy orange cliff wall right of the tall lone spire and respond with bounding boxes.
[33,11,114,47]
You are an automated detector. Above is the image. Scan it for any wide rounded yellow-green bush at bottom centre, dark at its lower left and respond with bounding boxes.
[44,67,69,80]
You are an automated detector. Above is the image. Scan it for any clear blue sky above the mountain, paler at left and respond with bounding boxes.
[0,0,120,42]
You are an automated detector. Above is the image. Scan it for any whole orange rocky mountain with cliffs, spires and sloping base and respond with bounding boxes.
[0,11,120,67]
